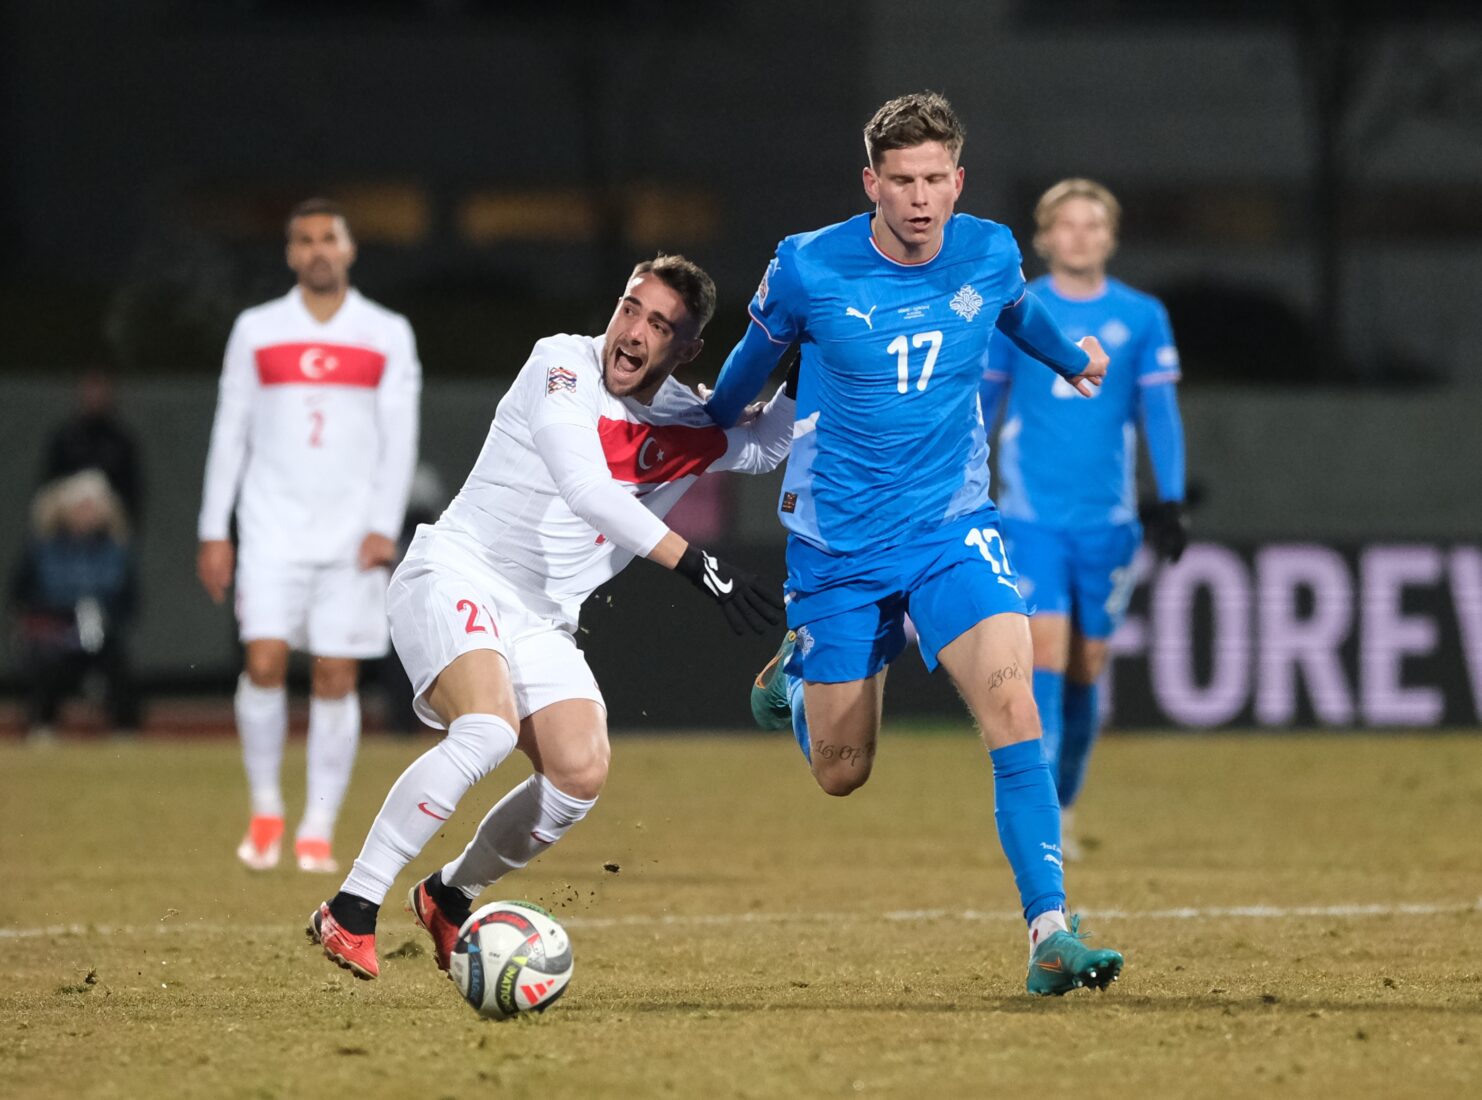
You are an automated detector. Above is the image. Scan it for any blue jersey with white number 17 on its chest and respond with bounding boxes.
[711,213,1031,556]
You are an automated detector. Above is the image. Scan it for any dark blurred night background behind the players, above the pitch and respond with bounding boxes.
[0,0,1482,725]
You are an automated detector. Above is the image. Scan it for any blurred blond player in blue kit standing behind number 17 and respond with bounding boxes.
[980,179,1187,858]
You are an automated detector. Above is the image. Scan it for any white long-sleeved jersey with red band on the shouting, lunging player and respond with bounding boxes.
[429,335,794,629]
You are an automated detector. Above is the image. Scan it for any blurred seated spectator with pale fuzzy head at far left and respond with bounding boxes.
[10,470,138,740]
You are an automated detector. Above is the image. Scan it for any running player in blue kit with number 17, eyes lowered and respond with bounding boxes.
[710,93,1122,993]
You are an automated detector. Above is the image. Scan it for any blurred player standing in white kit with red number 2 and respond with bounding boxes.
[196,199,422,872]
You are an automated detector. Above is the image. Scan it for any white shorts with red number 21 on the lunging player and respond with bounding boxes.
[387,538,608,729]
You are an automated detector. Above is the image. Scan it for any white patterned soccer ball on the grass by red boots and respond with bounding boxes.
[449,901,571,1020]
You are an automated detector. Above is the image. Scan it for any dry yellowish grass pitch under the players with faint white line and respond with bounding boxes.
[0,731,1482,1100]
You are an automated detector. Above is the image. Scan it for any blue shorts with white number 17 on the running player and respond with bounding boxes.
[787,507,1029,683]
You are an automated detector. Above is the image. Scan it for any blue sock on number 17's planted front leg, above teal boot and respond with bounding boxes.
[988,741,1066,921]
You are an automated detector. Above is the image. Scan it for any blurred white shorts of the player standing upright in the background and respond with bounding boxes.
[236,554,390,660]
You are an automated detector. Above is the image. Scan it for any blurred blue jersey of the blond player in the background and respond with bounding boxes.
[984,277,1181,531]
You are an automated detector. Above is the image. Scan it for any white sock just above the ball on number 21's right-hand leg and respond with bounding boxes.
[443,774,597,900]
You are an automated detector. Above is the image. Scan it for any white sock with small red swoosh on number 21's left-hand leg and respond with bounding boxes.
[341,715,516,904]
